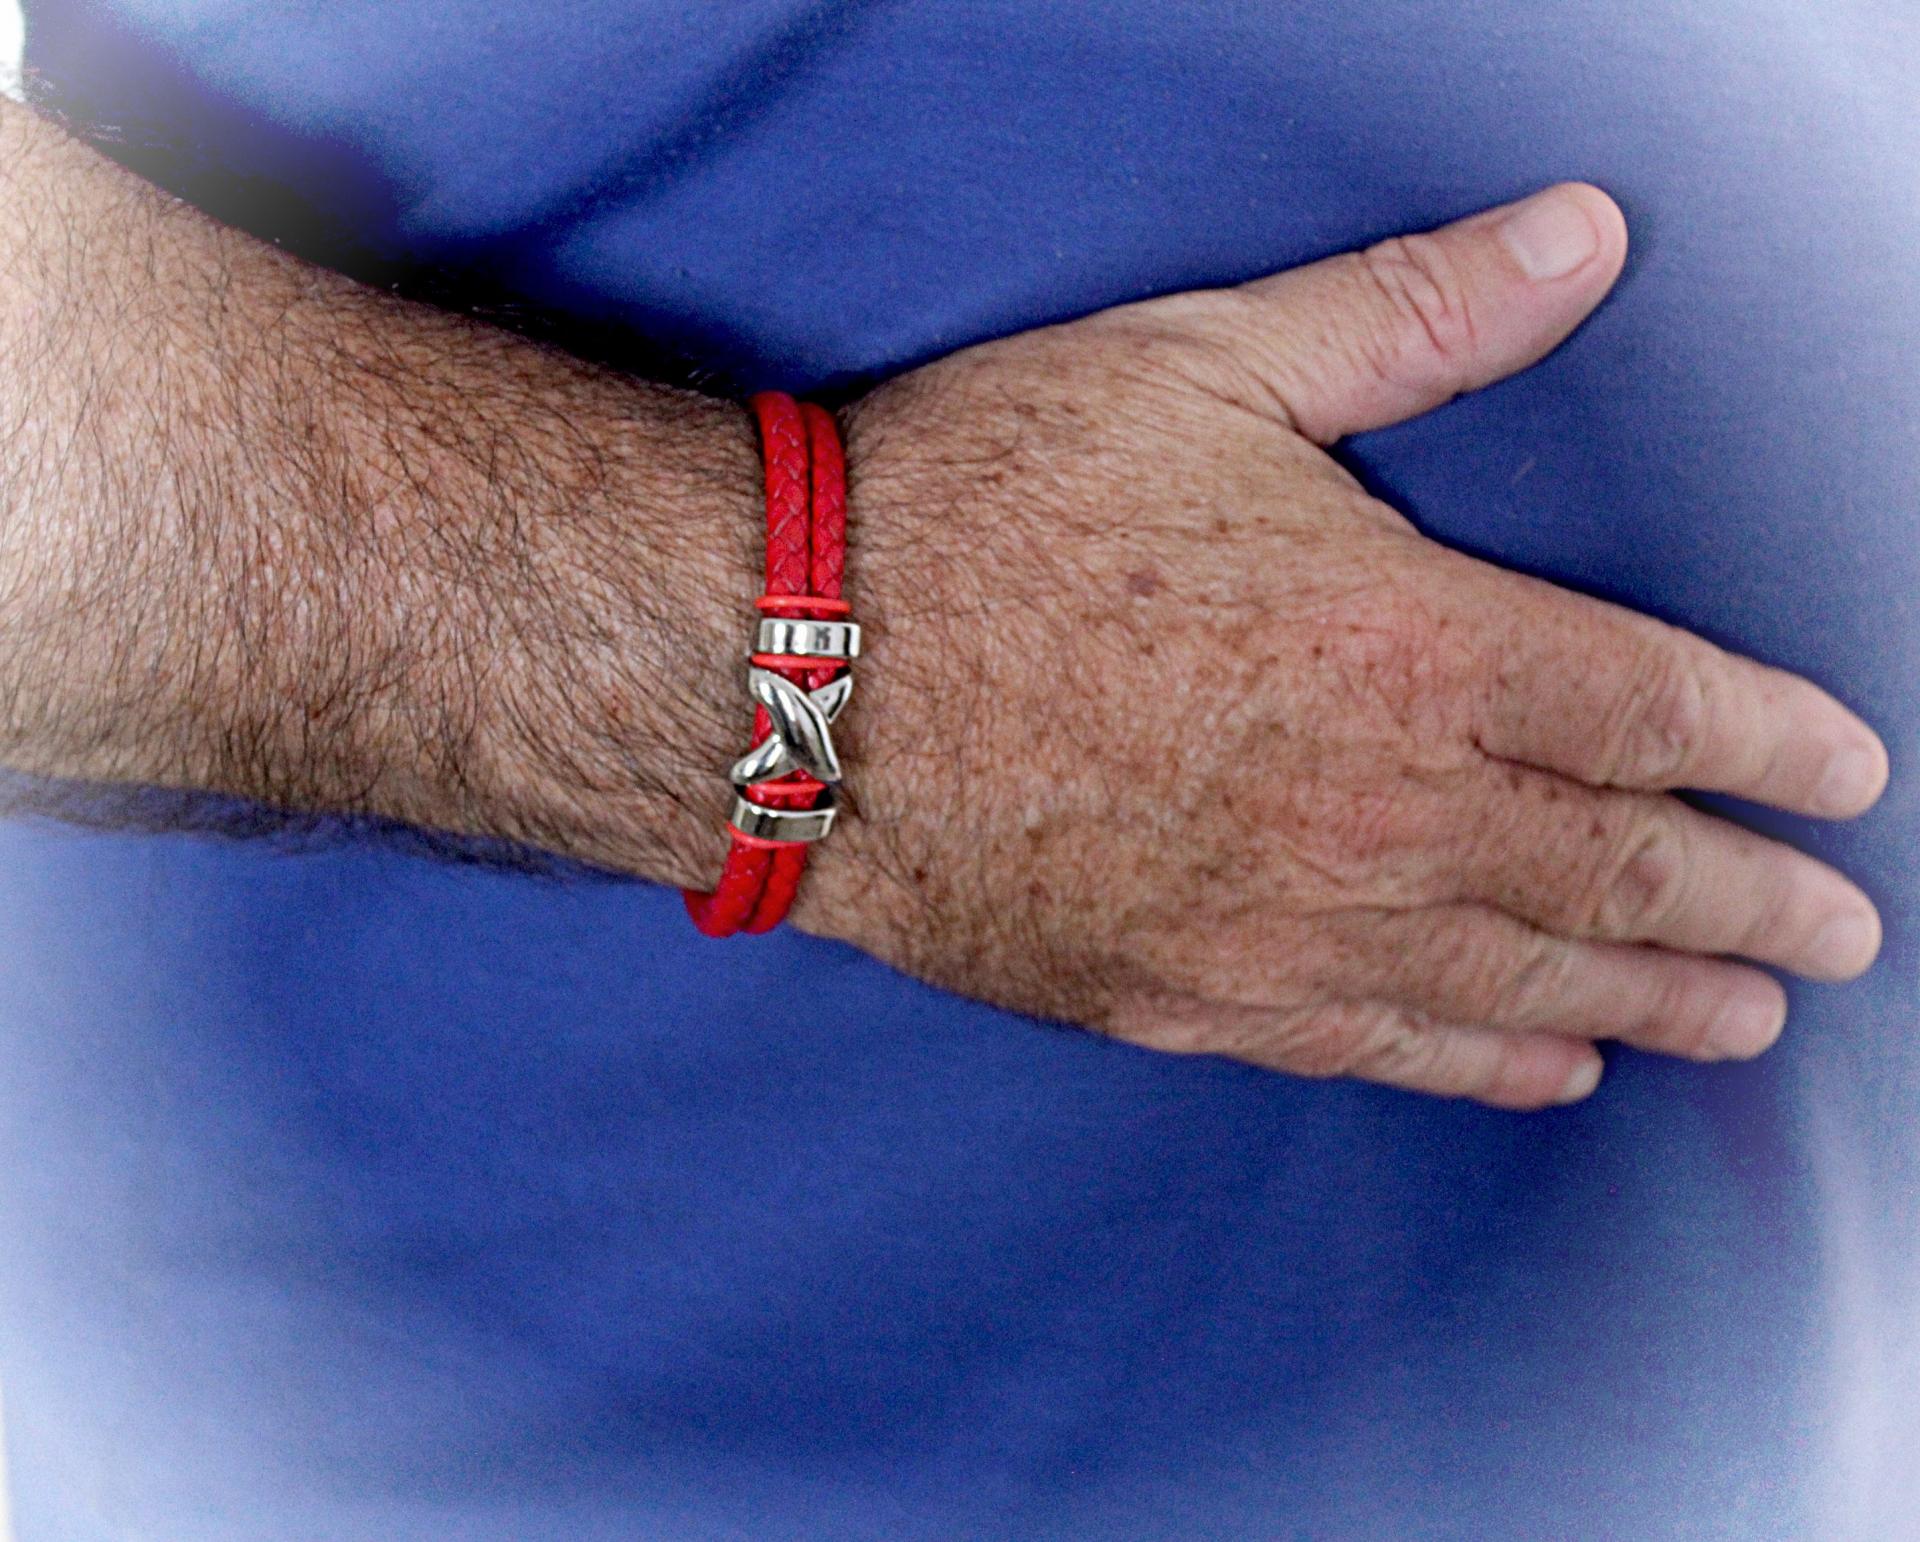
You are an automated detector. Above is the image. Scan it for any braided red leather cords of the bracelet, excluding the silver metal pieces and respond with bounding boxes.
[684,392,847,937]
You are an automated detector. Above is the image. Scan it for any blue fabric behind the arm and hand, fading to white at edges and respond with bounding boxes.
[0,0,1920,1542]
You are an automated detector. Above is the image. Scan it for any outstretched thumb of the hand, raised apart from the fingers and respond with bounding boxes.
[1229,182,1626,444]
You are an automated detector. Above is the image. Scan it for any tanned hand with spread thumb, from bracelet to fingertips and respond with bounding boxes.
[795,184,1887,1108]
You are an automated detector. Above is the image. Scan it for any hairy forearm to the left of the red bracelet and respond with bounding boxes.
[0,104,756,881]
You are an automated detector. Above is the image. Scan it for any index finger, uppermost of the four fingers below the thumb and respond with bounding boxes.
[1467,559,1887,818]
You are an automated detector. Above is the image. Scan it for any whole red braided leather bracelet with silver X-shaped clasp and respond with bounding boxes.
[684,392,860,937]
